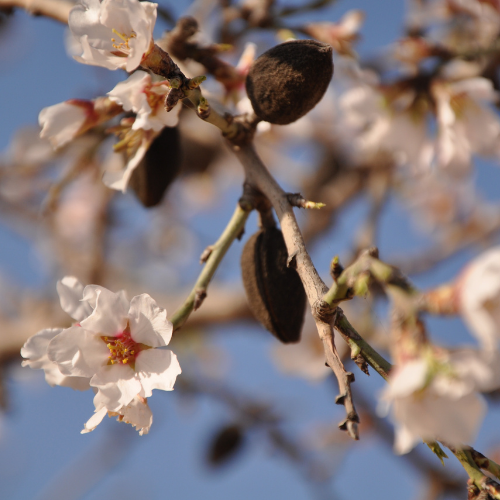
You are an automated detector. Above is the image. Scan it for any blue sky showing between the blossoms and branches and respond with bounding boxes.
[0,0,500,500]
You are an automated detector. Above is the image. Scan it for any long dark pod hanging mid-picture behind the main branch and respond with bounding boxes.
[241,227,306,344]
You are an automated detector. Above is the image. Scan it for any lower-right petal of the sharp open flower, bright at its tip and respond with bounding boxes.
[135,349,181,398]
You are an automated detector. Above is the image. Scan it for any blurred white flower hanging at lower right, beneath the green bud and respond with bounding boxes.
[379,349,500,454]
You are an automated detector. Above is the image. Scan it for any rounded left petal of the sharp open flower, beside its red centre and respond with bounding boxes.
[47,326,109,377]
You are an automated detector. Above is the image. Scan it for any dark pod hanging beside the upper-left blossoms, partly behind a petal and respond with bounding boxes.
[129,127,181,208]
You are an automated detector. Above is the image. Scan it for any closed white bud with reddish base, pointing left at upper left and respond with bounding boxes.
[38,98,121,149]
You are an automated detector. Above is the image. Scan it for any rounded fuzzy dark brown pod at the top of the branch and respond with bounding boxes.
[246,40,333,125]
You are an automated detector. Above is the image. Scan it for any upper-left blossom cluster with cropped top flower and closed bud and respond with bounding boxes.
[39,0,181,191]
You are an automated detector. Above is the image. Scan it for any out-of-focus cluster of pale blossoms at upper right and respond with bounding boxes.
[338,61,500,174]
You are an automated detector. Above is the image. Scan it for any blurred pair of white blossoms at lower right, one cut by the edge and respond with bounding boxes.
[380,247,500,453]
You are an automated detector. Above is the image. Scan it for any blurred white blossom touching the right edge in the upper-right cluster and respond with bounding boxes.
[431,77,500,172]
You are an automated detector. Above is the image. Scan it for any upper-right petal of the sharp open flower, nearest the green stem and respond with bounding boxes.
[128,293,173,347]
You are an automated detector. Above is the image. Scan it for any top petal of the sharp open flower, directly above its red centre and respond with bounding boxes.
[80,285,128,336]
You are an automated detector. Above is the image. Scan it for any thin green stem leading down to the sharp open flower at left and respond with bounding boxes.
[170,205,250,332]
